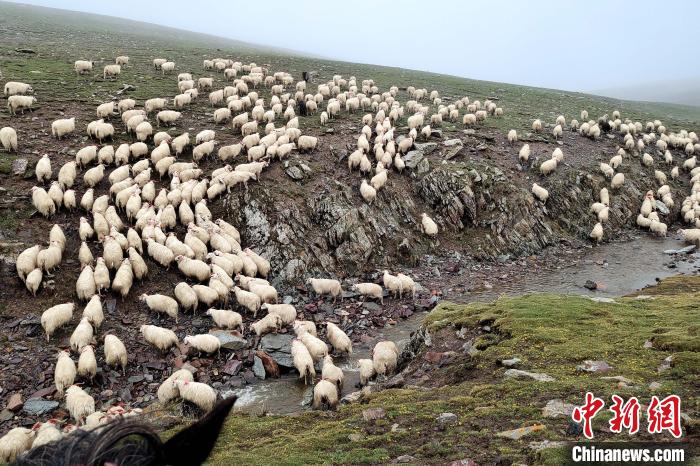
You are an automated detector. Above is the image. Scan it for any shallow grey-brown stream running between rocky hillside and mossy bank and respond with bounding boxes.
[228,237,700,414]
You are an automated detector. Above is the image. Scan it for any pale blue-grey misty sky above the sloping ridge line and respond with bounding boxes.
[5,0,700,99]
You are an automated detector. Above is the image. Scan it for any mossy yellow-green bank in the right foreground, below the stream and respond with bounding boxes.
[204,277,700,465]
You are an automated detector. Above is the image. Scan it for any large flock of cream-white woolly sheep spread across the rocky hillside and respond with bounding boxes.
[0,49,700,461]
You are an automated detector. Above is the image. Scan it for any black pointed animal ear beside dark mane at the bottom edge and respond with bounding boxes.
[163,396,236,466]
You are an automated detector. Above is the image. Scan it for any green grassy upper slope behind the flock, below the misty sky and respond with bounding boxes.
[0,2,700,130]
